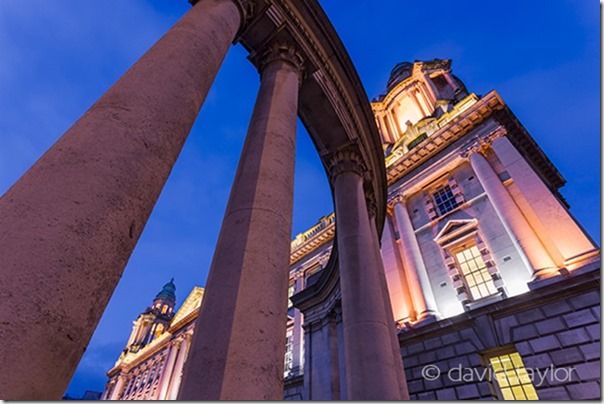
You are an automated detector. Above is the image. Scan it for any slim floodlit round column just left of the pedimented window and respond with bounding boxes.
[392,195,438,320]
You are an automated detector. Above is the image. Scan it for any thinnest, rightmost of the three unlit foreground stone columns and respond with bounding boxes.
[329,150,403,400]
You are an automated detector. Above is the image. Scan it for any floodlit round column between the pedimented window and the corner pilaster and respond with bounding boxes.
[470,151,556,278]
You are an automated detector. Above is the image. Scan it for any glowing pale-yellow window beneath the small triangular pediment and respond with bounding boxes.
[455,245,497,300]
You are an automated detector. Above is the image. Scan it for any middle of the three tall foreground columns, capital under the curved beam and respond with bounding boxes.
[179,42,301,400]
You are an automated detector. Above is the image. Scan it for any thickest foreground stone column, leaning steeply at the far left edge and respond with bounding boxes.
[0,0,241,400]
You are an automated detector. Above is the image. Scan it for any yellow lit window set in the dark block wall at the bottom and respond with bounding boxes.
[489,352,539,400]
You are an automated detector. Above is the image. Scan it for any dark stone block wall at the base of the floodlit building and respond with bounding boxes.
[399,268,601,400]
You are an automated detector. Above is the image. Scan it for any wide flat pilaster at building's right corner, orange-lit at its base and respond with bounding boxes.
[491,136,599,267]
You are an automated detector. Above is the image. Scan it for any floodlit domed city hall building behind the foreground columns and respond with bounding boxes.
[102,60,600,400]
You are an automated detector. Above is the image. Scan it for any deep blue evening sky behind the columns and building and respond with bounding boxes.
[0,0,600,396]
